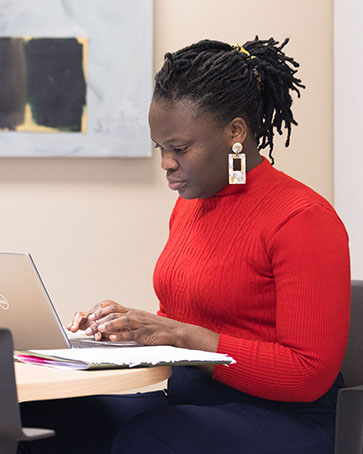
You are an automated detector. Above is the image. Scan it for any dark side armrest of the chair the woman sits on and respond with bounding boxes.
[334,385,363,454]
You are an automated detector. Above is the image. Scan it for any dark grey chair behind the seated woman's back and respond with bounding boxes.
[335,281,363,454]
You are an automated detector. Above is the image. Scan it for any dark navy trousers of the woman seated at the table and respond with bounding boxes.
[18,366,344,454]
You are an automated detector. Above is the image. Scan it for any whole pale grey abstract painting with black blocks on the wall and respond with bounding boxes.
[0,0,153,157]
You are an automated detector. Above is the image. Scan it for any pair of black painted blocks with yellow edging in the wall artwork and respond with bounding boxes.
[0,38,86,132]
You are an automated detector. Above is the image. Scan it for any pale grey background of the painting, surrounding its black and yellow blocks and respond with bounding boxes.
[0,0,153,157]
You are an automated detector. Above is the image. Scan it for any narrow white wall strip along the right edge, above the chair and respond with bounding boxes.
[334,0,363,279]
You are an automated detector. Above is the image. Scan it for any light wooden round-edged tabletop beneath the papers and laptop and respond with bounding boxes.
[15,363,171,402]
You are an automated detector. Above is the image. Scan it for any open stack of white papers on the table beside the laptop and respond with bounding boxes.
[14,345,236,369]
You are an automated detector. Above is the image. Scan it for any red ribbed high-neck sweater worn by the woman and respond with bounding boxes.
[154,159,350,401]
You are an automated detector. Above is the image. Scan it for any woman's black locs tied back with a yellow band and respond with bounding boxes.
[153,36,305,164]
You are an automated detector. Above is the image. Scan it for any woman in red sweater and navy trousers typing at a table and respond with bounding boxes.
[18,38,350,454]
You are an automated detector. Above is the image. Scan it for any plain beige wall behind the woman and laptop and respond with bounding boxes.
[0,0,333,321]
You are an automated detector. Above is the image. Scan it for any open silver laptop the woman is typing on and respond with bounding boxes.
[0,252,140,350]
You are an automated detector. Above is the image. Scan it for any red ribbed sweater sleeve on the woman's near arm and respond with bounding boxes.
[214,204,350,402]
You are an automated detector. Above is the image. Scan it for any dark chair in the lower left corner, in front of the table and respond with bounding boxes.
[0,328,54,454]
